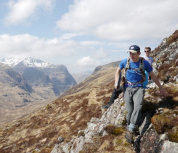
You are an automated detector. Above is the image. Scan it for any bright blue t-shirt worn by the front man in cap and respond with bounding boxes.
[120,58,153,87]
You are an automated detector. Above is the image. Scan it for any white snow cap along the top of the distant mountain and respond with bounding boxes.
[0,57,53,68]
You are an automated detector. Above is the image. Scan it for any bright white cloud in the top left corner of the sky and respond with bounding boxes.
[5,0,54,24]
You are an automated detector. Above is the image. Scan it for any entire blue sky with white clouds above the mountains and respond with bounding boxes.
[0,0,178,73]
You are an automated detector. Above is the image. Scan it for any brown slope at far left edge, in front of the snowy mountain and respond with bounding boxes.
[0,64,55,124]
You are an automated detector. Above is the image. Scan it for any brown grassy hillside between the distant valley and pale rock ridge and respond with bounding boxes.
[0,59,116,152]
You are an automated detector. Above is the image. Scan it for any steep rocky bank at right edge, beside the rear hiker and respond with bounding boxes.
[152,30,178,83]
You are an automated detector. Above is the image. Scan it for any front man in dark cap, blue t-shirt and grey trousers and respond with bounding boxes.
[115,45,167,143]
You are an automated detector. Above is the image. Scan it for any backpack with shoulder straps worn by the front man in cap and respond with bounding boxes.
[121,57,148,88]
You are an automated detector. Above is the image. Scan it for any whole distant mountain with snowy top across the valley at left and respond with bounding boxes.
[0,58,76,124]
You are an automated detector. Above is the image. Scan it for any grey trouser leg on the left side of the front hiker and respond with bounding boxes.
[124,88,134,125]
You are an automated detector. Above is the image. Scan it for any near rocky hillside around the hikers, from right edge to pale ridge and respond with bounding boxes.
[51,31,178,153]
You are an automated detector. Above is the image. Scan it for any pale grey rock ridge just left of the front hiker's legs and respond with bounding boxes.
[51,94,126,153]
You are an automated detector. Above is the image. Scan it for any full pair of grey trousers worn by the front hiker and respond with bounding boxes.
[124,87,145,128]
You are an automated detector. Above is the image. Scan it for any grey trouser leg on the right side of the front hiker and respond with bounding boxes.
[130,88,145,125]
